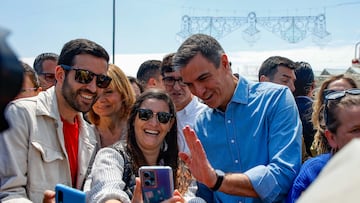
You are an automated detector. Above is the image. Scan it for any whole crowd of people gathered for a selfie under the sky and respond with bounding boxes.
[0,31,360,203]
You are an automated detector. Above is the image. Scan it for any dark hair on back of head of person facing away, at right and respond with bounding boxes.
[294,61,315,96]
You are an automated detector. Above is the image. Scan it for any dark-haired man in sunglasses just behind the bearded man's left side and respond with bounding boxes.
[33,53,59,90]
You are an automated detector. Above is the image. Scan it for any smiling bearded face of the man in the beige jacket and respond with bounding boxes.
[56,54,108,112]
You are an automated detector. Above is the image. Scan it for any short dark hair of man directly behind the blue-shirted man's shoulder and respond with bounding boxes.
[258,56,296,80]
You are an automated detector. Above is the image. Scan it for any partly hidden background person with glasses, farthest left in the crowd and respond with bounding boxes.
[15,62,42,99]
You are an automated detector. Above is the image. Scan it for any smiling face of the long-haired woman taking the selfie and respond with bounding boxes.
[134,98,173,152]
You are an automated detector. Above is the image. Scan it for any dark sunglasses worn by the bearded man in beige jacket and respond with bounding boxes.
[60,65,112,88]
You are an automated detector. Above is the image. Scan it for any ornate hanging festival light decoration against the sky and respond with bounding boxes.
[177,12,330,46]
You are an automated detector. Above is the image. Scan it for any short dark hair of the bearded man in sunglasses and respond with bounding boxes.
[58,39,109,66]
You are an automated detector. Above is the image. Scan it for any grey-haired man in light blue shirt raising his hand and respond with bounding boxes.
[173,34,302,203]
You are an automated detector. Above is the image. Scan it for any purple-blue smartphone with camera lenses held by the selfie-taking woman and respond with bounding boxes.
[139,166,174,203]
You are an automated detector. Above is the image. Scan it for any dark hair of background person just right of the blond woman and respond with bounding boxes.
[136,60,161,86]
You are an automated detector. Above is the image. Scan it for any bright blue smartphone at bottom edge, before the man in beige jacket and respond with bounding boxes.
[55,184,86,203]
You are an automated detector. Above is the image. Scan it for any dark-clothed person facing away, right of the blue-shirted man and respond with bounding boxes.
[293,61,316,161]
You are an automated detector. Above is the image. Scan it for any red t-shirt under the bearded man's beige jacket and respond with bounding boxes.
[61,117,79,187]
